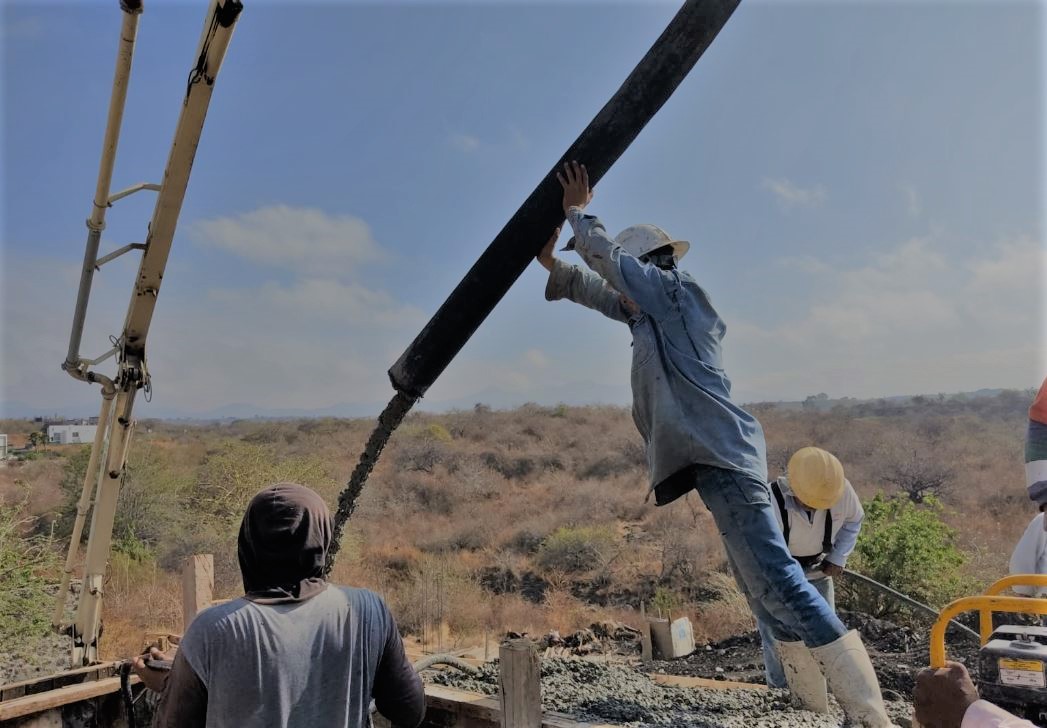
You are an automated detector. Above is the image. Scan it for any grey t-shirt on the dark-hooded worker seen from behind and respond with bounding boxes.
[172,584,417,728]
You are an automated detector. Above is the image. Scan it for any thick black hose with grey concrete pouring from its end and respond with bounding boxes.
[326,0,741,574]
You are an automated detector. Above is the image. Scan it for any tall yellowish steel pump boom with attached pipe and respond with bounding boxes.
[58,0,243,666]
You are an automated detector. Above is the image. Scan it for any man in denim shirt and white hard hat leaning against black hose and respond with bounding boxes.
[538,162,891,727]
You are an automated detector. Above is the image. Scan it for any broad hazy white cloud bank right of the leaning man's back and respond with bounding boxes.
[725,237,1047,400]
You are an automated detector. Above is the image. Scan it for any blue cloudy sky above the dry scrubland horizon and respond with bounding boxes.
[0,0,1047,416]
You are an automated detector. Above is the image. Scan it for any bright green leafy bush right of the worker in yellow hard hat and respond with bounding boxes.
[841,493,968,617]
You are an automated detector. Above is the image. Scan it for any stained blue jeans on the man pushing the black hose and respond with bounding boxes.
[695,465,847,647]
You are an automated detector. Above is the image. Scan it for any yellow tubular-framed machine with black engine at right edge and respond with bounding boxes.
[931,574,1047,725]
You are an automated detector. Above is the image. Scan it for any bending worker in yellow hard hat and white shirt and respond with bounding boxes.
[757,447,865,704]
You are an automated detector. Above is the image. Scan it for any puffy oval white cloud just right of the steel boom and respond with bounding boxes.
[191,205,383,273]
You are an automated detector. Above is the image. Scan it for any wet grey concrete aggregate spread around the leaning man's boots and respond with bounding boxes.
[425,658,911,728]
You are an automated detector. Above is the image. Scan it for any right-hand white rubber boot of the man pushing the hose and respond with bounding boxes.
[812,630,894,728]
